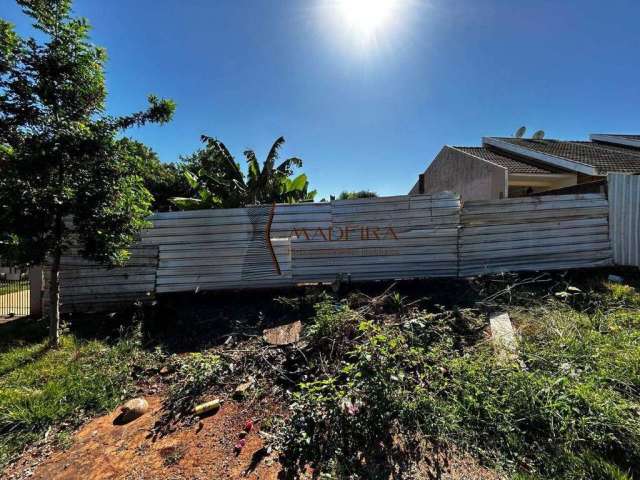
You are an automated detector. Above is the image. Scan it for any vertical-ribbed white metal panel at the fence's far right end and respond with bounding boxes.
[608,173,640,267]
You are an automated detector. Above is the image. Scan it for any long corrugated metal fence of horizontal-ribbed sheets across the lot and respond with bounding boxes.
[38,192,612,312]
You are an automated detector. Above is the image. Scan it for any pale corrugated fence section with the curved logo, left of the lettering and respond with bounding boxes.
[149,203,331,293]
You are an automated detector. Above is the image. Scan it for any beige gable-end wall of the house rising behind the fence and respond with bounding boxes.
[409,146,507,200]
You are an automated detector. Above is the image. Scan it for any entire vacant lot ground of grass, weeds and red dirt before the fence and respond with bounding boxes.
[0,270,640,480]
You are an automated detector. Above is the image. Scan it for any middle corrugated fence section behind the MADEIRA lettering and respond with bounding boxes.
[292,193,460,282]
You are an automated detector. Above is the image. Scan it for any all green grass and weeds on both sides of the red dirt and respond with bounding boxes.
[0,273,640,480]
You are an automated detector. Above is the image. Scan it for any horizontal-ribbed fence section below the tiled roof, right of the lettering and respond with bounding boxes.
[459,194,612,277]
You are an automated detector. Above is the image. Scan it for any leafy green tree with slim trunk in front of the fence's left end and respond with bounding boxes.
[0,0,175,346]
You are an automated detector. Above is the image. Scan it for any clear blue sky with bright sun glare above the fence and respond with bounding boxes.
[0,0,640,196]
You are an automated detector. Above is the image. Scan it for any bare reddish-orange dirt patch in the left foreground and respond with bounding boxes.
[5,397,280,480]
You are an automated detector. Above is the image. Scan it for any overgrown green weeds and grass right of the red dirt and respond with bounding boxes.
[280,274,640,479]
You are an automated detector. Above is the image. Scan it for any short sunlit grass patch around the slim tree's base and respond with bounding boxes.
[0,322,155,467]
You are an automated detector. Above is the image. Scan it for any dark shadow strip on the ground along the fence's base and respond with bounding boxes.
[0,268,640,353]
